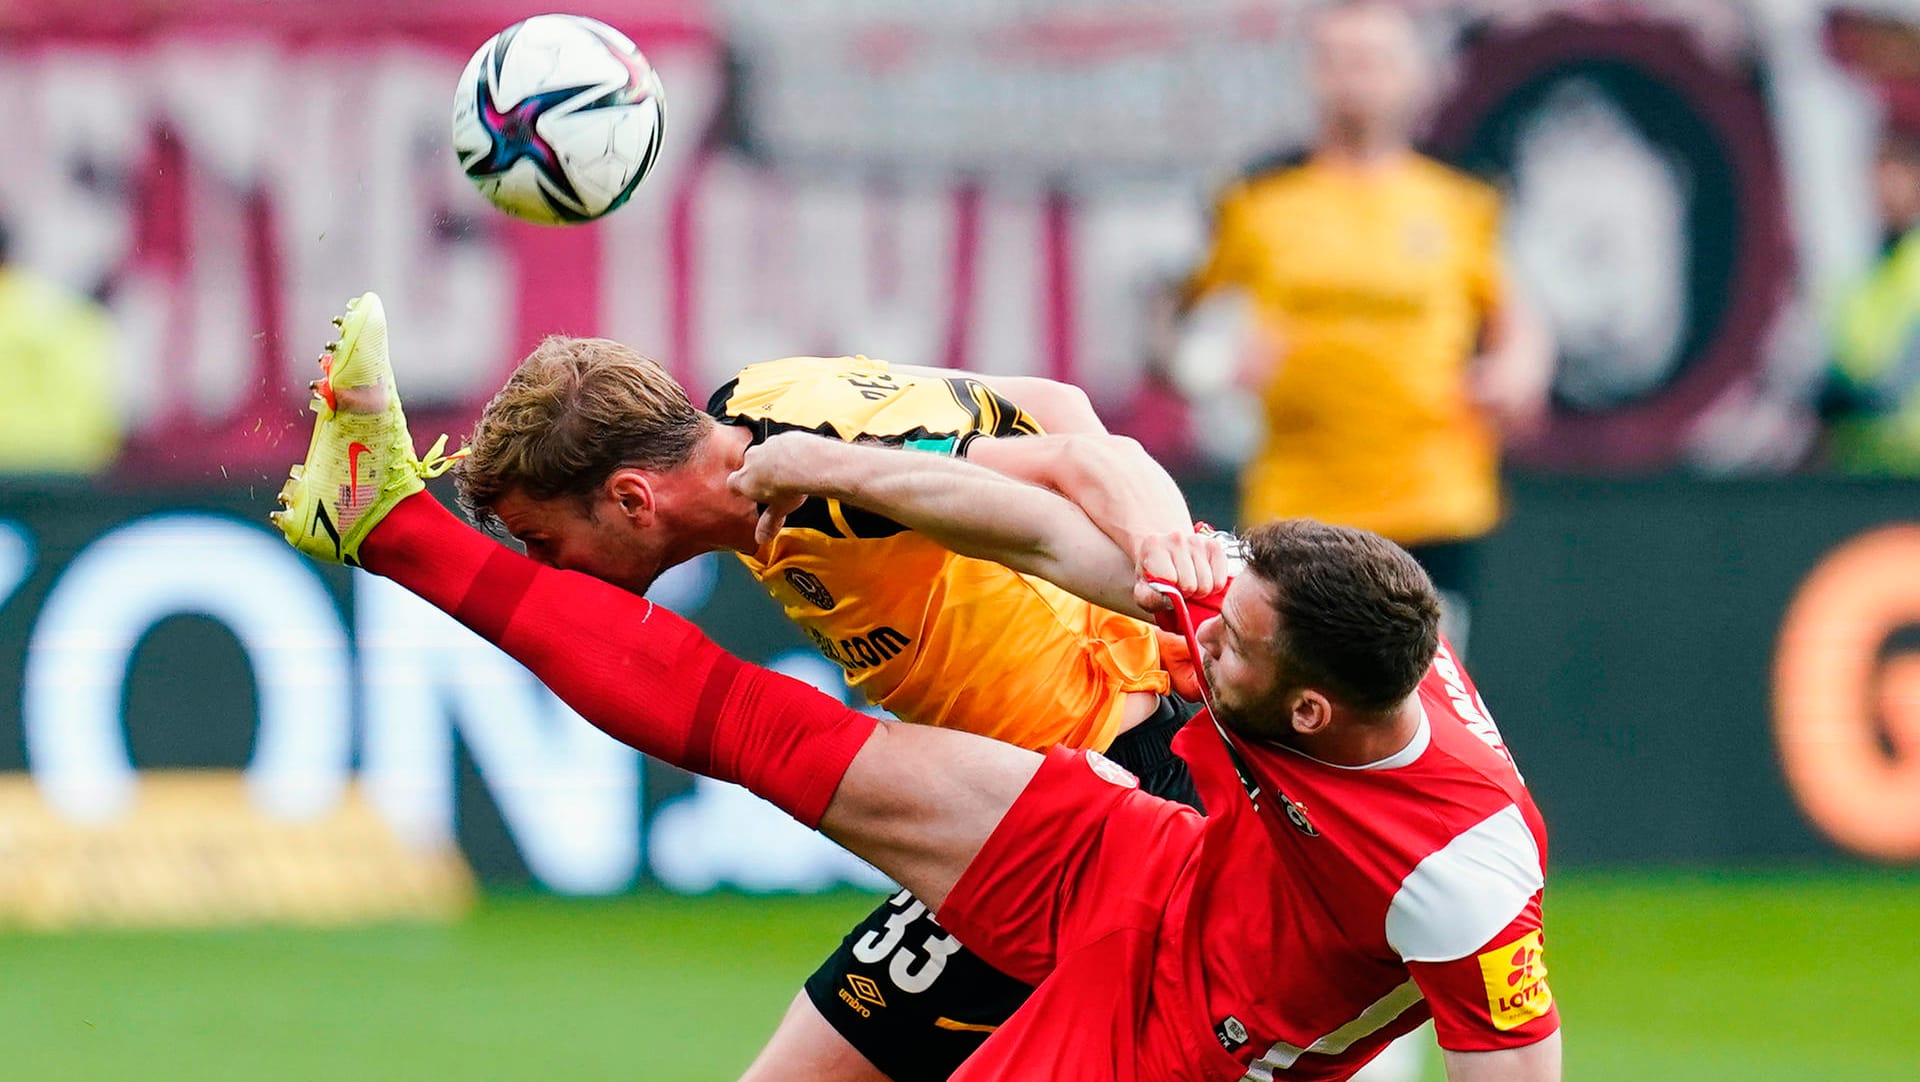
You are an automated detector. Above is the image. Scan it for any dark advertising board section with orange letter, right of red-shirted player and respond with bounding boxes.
[1471,478,1920,865]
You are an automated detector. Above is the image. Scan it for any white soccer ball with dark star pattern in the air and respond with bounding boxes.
[453,15,666,224]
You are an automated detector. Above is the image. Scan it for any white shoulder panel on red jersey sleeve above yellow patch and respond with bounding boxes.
[1386,804,1546,961]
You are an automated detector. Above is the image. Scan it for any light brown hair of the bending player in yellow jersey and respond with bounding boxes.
[455,336,712,529]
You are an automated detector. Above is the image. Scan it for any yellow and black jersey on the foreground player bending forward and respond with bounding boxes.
[707,357,1167,750]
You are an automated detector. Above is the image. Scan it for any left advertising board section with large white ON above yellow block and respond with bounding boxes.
[0,485,883,927]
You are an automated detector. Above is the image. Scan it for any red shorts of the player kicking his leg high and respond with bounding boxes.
[939,748,1219,1082]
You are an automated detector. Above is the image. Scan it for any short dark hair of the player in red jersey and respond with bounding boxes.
[1244,518,1440,714]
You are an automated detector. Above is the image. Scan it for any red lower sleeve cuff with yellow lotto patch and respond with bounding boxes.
[1407,892,1559,1051]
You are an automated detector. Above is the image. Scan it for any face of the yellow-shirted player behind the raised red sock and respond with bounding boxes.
[493,493,664,595]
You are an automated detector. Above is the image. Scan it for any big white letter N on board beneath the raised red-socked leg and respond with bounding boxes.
[353,572,639,894]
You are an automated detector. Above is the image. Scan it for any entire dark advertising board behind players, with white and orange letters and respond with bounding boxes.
[0,480,1920,927]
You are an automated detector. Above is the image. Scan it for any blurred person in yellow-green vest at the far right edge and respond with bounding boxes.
[1820,130,1920,476]
